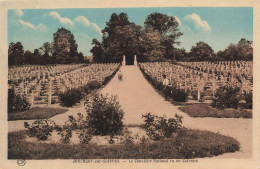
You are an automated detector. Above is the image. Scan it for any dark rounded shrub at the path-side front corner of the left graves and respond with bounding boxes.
[59,89,83,107]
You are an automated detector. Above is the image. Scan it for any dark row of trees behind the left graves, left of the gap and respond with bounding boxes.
[8,28,84,65]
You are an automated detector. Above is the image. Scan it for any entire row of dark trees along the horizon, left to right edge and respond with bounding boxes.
[8,12,253,65]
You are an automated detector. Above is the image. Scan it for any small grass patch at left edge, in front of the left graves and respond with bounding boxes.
[8,107,68,121]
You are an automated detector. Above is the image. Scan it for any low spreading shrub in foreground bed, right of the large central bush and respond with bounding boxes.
[142,113,182,140]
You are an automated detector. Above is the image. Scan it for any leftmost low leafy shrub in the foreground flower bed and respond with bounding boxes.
[24,119,56,140]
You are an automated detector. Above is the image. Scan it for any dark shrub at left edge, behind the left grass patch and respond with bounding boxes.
[8,89,30,113]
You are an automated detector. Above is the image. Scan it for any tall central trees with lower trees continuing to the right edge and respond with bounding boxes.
[90,12,253,62]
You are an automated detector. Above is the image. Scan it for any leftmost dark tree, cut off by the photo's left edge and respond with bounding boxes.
[8,42,24,65]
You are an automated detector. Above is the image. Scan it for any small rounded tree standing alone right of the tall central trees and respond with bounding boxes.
[190,42,214,61]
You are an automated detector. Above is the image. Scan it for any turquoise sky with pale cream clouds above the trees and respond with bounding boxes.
[8,7,253,56]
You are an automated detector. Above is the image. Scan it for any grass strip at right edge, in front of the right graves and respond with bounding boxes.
[179,103,252,118]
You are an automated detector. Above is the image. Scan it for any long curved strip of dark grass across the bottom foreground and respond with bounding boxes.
[8,129,239,159]
